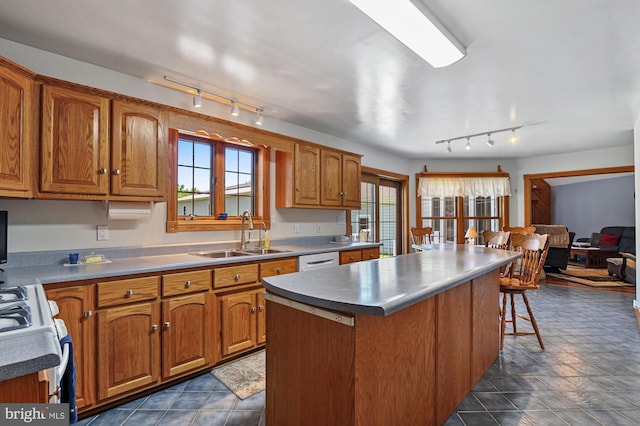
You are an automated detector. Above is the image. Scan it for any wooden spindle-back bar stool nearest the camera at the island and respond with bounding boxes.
[500,234,549,350]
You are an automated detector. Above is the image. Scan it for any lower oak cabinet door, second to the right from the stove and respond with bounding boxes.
[97,302,160,399]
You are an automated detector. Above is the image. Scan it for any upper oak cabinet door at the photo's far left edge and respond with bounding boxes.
[0,62,36,198]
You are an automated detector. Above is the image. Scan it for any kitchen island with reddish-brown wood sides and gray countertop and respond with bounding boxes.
[263,245,519,425]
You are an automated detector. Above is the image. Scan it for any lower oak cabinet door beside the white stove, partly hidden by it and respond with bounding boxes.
[47,285,96,408]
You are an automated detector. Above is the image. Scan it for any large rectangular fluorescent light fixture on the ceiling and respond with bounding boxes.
[349,0,467,68]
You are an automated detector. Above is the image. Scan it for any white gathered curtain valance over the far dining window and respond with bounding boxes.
[418,177,511,198]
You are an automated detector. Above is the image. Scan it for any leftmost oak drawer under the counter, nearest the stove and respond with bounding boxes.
[98,277,160,307]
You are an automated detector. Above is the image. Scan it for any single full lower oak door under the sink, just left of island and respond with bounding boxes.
[220,291,257,357]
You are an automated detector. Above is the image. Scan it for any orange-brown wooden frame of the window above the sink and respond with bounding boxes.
[167,128,271,233]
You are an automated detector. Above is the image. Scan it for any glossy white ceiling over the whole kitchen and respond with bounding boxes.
[0,0,640,158]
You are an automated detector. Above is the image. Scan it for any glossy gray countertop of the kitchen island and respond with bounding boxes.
[263,244,520,316]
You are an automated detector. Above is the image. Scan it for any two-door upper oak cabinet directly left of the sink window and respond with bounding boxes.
[40,84,169,201]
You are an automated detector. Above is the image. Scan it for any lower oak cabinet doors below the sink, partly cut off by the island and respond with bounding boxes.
[220,288,266,358]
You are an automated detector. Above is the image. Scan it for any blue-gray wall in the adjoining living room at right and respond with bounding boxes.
[552,176,635,238]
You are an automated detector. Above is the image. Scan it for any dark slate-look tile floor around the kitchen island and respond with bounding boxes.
[81,285,640,426]
